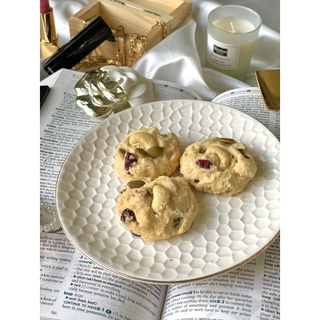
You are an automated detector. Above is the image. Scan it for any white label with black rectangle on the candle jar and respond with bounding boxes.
[207,35,240,70]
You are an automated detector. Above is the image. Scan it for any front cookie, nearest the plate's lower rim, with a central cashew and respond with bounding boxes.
[117,176,198,241]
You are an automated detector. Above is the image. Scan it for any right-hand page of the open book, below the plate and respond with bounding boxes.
[162,239,280,320]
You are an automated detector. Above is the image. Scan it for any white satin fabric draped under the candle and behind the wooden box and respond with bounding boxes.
[46,0,280,101]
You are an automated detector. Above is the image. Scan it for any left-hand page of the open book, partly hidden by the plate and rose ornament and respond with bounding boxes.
[40,69,202,320]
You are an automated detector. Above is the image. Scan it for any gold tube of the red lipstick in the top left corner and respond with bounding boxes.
[40,3,58,59]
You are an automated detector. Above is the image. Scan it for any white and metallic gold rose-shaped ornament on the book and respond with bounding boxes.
[74,66,154,117]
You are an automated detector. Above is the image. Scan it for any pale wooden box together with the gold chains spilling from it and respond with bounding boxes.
[69,0,192,66]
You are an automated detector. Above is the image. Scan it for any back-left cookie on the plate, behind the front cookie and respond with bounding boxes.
[114,127,180,181]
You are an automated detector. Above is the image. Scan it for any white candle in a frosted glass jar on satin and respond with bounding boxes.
[207,5,262,80]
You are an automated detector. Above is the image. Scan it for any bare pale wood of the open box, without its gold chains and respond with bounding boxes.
[69,0,192,66]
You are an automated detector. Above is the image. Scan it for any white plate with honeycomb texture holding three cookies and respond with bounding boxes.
[56,100,280,284]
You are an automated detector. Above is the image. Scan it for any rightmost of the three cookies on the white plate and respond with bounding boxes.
[180,137,257,196]
